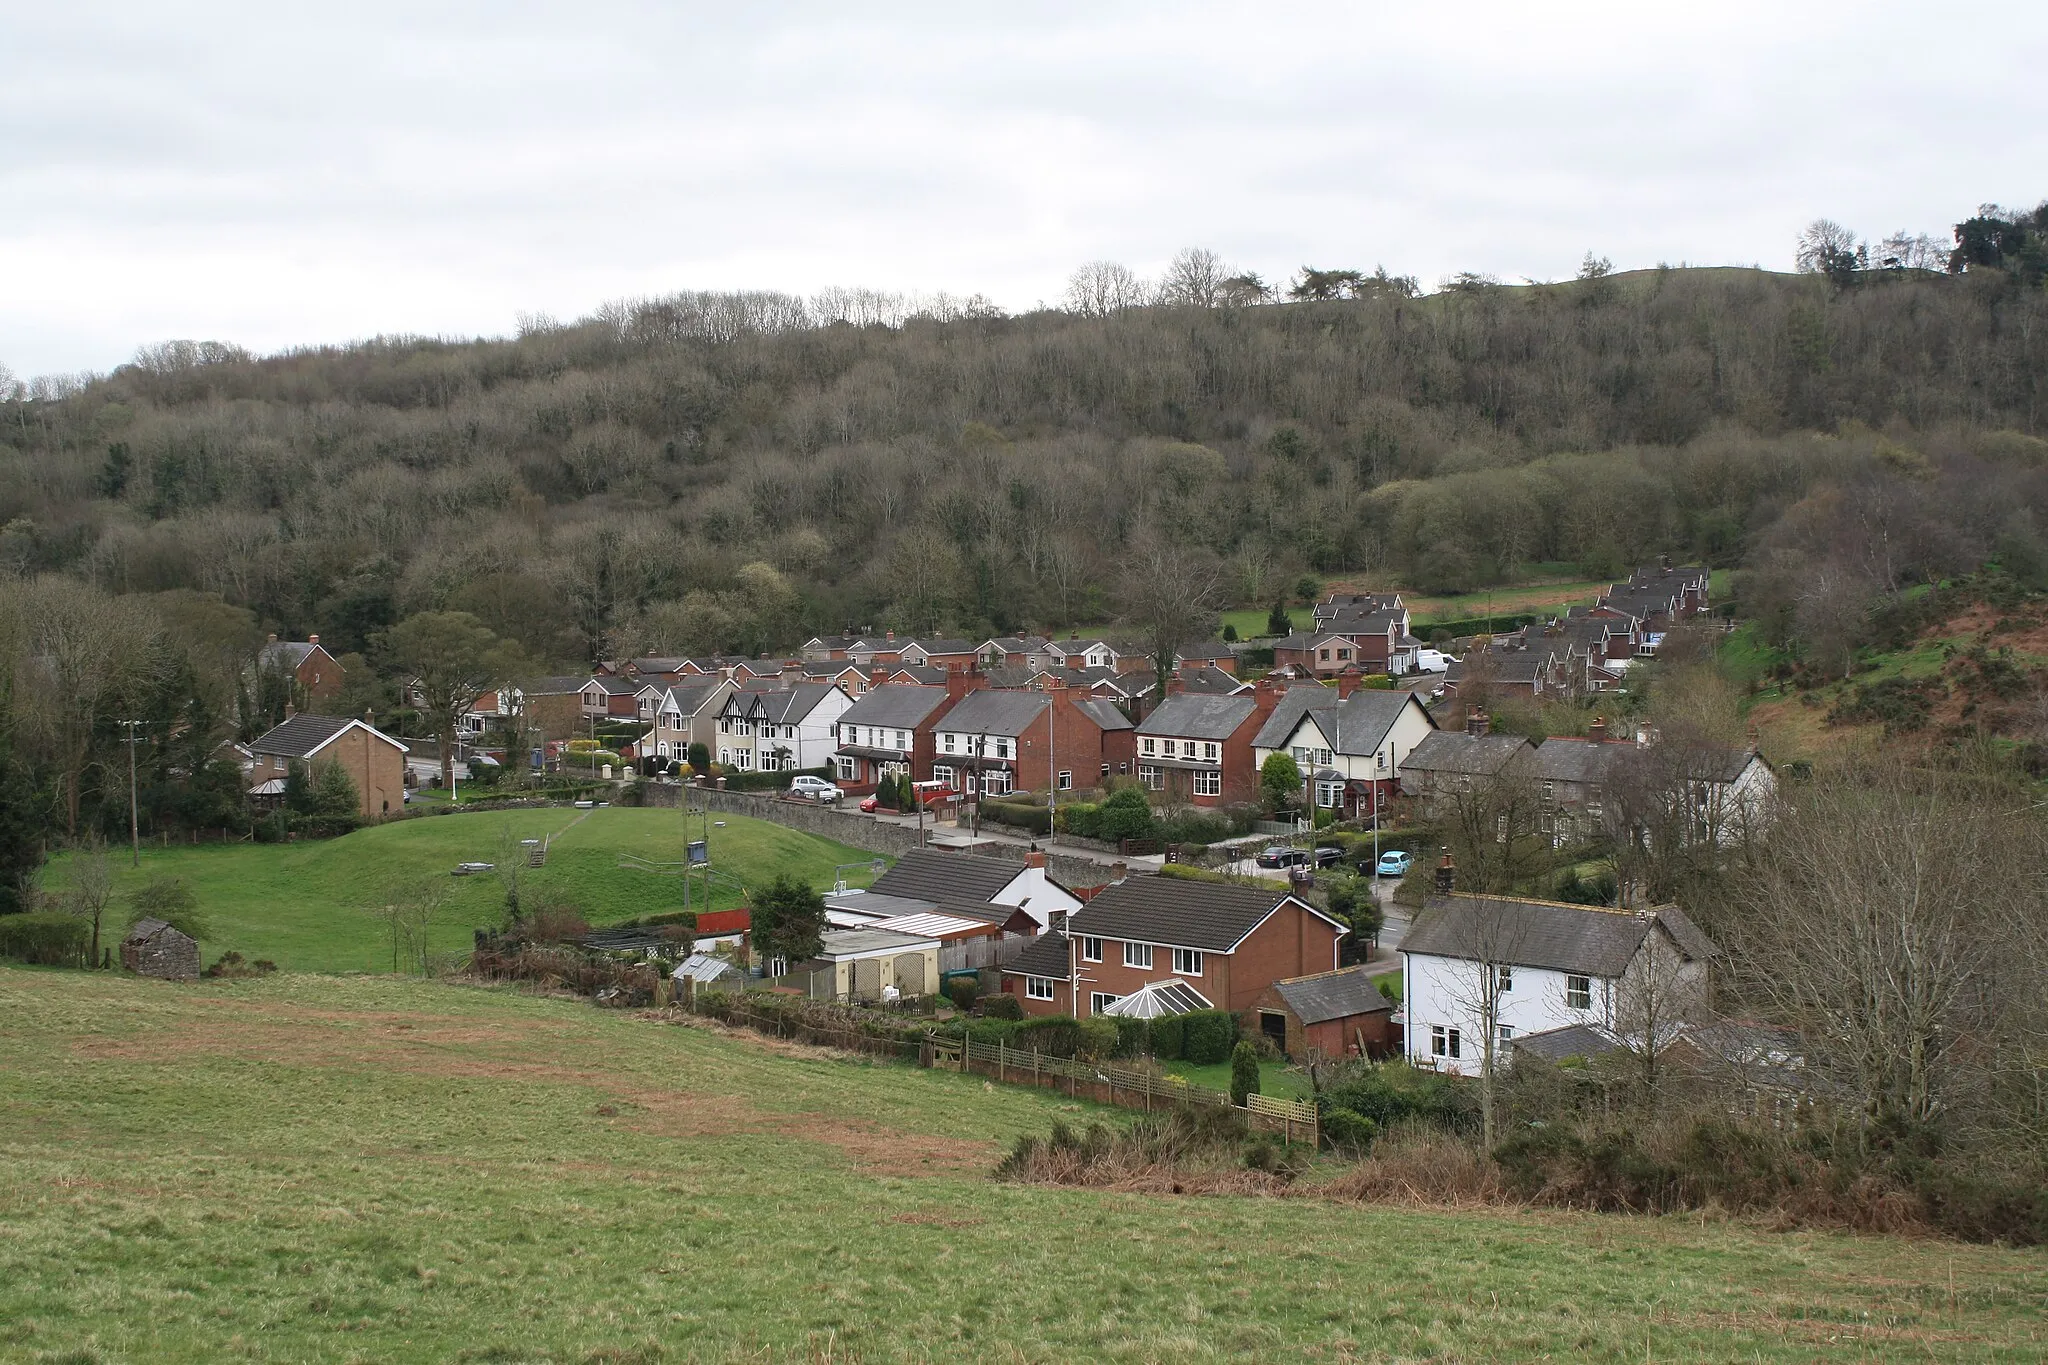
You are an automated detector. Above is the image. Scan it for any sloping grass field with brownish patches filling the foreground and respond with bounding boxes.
[0,968,2048,1363]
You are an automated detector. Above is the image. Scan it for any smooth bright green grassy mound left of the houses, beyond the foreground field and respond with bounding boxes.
[47,806,872,972]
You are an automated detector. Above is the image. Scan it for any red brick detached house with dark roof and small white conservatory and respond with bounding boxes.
[1004,876,1346,1017]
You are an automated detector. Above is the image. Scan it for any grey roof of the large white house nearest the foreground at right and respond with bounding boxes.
[1401,896,1714,980]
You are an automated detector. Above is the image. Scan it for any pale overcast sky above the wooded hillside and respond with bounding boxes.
[0,0,2048,377]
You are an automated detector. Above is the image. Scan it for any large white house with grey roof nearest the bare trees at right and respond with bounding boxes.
[1401,894,1714,1076]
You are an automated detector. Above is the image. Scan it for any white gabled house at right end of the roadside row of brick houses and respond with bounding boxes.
[1251,684,1436,819]
